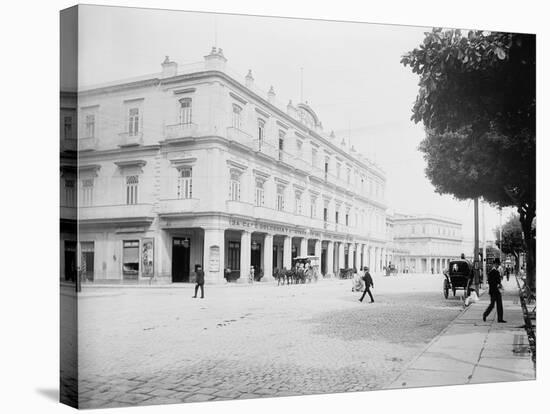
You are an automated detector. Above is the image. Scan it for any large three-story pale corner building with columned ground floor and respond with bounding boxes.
[62,48,386,282]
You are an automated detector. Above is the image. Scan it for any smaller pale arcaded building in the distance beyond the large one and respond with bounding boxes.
[389,214,462,273]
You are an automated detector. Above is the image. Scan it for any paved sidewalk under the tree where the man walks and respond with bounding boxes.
[384,280,536,389]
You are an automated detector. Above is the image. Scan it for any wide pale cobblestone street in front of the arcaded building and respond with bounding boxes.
[68,275,462,408]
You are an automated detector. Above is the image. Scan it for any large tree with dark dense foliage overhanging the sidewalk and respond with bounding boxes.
[401,29,536,288]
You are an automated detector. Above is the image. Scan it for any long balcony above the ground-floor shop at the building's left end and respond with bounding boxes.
[78,203,154,224]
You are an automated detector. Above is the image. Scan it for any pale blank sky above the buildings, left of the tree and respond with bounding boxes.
[79,6,512,244]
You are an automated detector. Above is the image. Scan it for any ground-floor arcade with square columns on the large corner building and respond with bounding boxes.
[71,217,390,283]
